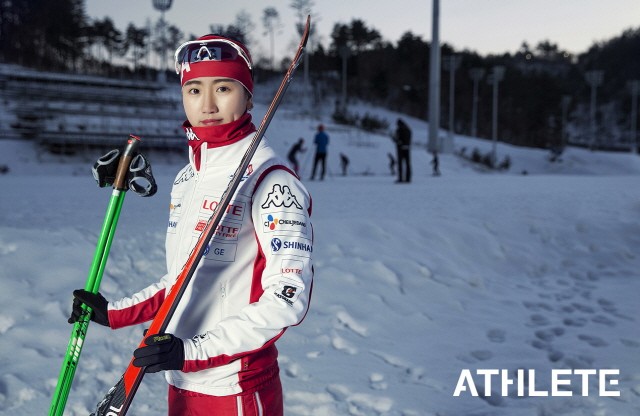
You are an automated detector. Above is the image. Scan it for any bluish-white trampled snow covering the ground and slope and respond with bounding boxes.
[0,96,640,416]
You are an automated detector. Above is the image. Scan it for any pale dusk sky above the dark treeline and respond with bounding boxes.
[86,0,640,64]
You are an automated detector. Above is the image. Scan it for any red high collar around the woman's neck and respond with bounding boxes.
[182,113,256,170]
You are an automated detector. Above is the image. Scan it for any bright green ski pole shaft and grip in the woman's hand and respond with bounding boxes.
[49,135,140,416]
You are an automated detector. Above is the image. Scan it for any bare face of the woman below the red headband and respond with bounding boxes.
[182,77,253,127]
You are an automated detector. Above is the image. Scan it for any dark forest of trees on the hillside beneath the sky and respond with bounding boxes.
[0,0,640,149]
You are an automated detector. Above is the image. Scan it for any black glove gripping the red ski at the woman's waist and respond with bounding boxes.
[133,334,184,373]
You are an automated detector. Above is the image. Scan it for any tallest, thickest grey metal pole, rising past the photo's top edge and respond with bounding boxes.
[427,0,440,152]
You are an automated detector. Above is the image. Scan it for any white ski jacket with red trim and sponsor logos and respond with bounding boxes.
[109,134,313,396]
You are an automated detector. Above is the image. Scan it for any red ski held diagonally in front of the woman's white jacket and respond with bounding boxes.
[91,16,311,416]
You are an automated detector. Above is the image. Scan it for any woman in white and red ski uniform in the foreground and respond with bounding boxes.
[69,30,313,416]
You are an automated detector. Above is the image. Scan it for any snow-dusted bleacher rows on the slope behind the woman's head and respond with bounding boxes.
[0,65,185,152]
